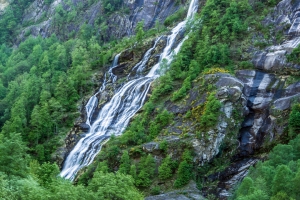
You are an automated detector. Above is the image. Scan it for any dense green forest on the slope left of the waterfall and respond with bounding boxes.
[0,36,101,161]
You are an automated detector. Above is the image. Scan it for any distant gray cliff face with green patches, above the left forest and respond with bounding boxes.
[16,0,179,44]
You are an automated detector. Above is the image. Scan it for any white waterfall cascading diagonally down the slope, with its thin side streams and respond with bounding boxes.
[60,0,198,180]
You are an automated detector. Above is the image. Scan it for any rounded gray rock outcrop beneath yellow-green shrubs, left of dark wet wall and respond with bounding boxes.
[192,73,245,165]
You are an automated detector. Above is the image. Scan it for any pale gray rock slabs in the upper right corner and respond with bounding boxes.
[252,0,300,73]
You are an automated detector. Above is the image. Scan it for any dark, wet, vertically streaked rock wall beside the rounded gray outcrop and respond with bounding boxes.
[236,70,300,155]
